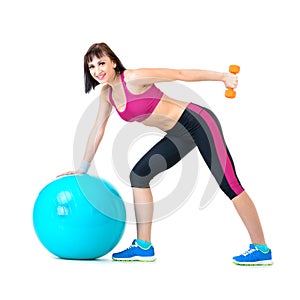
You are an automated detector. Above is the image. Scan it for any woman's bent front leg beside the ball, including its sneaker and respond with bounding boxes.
[112,130,196,261]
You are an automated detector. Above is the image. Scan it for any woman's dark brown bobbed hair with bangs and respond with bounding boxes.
[84,43,126,93]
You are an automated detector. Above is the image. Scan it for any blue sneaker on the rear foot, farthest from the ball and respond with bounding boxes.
[233,244,273,266]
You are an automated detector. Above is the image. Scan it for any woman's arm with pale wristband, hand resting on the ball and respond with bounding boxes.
[58,87,112,177]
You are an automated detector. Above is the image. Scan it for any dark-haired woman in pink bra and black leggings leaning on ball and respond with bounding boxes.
[62,43,272,265]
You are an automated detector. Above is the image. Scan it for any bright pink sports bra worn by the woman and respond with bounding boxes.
[109,72,163,122]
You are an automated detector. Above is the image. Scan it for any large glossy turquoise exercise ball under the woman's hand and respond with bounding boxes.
[33,174,126,259]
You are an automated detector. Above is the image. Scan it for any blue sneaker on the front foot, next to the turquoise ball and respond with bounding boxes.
[112,240,156,261]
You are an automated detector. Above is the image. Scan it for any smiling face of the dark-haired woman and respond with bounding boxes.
[88,55,116,83]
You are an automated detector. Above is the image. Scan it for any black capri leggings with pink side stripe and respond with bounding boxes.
[130,103,244,199]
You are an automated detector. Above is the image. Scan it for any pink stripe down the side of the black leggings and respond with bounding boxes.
[188,103,244,195]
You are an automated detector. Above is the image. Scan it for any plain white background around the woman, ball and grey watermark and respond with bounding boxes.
[0,0,300,299]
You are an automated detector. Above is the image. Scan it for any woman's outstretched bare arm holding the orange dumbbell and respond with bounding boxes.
[128,68,237,88]
